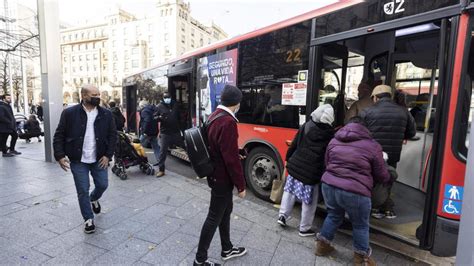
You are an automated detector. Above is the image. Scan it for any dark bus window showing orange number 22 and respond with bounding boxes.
[237,21,311,128]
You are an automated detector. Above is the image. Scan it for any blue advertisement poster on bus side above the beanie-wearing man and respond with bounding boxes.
[198,49,238,121]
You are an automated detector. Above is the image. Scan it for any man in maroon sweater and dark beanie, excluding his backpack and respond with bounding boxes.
[194,85,247,265]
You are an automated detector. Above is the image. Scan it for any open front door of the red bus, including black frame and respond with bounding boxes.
[307,14,458,256]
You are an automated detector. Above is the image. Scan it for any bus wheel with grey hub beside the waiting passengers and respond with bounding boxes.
[245,147,281,201]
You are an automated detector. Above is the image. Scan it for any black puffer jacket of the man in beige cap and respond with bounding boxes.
[360,98,416,163]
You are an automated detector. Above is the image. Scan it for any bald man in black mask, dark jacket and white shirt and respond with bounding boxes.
[53,85,117,234]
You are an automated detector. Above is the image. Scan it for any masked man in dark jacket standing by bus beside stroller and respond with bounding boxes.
[154,92,184,177]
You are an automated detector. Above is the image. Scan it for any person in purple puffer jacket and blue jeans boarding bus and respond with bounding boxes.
[315,116,390,265]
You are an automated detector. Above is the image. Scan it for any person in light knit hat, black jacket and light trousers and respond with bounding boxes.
[278,104,334,237]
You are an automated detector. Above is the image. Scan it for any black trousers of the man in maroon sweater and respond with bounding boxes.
[196,185,233,262]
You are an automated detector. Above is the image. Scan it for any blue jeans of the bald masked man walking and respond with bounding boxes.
[71,162,109,221]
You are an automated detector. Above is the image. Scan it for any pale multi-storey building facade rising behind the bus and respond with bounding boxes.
[61,0,227,106]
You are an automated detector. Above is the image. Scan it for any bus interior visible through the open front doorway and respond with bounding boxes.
[316,22,440,244]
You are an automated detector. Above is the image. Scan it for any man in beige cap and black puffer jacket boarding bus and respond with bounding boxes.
[360,85,416,219]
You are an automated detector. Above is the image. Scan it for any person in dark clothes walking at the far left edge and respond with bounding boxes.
[0,94,21,157]
